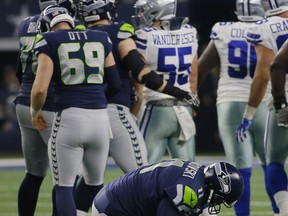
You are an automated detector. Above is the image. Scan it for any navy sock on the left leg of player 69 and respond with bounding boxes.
[54,185,76,216]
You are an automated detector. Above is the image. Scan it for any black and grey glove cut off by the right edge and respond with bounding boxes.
[274,96,288,127]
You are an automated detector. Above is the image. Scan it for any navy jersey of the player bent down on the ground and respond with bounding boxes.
[105,159,205,216]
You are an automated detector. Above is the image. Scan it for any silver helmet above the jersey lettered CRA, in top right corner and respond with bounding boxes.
[262,0,288,16]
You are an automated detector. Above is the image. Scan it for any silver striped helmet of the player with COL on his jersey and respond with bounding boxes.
[235,0,265,22]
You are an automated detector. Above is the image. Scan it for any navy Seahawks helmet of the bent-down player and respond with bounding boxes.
[204,162,244,214]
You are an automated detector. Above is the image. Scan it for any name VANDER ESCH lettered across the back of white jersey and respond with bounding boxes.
[152,32,196,45]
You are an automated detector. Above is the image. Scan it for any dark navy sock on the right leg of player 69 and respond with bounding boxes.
[75,178,103,212]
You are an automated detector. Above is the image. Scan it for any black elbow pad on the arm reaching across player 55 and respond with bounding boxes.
[122,49,146,81]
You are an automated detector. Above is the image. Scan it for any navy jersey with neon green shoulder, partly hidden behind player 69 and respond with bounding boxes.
[89,22,134,107]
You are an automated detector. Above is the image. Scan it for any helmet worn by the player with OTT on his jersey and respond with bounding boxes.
[37,5,75,33]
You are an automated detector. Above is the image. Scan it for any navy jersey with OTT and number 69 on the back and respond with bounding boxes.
[34,30,112,110]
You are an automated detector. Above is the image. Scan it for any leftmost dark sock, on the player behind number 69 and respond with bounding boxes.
[18,173,44,216]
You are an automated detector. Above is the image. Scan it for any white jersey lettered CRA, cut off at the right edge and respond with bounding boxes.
[247,16,288,95]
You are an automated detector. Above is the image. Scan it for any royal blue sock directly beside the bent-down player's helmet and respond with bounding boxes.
[234,168,252,216]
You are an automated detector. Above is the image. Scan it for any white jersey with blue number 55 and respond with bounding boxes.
[136,24,198,102]
